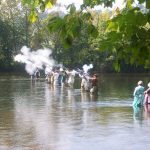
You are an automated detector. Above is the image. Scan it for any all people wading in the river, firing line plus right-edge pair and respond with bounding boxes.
[31,67,150,107]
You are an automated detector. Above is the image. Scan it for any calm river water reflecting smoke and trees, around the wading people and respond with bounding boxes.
[0,74,150,150]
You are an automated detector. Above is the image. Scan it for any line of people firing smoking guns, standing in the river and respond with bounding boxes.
[31,67,98,93]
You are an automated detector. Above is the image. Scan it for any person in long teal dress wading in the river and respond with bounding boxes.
[133,81,144,107]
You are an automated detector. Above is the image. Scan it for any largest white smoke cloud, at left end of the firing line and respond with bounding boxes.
[14,46,56,75]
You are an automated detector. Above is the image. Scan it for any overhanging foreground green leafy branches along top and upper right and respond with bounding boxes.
[22,0,150,70]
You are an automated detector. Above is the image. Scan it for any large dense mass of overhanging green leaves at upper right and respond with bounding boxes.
[101,7,150,70]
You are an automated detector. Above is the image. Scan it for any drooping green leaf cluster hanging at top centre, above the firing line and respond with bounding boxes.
[47,4,98,48]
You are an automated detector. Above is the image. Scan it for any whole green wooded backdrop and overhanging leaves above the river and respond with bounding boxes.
[0,0,150,72]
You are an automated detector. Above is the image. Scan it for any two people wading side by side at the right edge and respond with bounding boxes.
[133,81,150,107]
